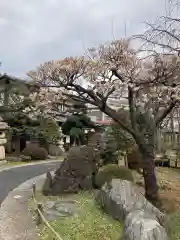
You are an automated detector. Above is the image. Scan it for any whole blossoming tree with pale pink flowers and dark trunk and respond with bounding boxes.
[28,39,179,203]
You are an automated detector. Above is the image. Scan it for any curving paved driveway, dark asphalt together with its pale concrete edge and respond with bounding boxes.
[0,160,61,240]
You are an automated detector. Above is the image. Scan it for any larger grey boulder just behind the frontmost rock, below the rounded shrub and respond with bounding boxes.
[96,179,166,225]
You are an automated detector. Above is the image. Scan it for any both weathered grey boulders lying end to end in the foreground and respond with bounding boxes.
[96,179,168,240]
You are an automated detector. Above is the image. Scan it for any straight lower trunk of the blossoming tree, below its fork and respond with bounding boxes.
[139,144,159,205]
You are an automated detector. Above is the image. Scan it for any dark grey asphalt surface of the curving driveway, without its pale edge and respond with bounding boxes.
[0,161,61,203]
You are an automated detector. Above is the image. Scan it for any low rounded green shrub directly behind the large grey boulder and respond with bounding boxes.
[95,164,133,188]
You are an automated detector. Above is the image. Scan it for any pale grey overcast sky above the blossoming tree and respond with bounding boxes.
[0,0,165,77]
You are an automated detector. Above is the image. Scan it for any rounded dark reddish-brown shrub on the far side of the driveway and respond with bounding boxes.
[22,144,48,160]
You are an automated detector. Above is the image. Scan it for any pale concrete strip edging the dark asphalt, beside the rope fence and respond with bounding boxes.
[0,172,53,240]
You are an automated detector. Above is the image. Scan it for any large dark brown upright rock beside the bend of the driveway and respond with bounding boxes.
[45,146,98,195]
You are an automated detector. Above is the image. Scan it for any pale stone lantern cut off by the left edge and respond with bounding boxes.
[0,117,8,161]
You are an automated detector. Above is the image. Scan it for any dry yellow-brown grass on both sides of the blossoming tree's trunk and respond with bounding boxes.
[133,167,180,240]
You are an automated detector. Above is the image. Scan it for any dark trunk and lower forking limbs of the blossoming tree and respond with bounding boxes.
[102,106,159,205]
